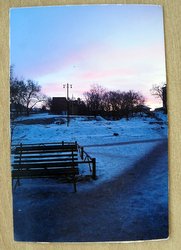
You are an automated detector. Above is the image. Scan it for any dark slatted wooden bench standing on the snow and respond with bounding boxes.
[12,142,79,192]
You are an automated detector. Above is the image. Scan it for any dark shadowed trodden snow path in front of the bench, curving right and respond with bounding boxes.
[13,140,168,242]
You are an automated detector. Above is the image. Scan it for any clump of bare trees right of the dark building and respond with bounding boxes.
[84,85,145,119]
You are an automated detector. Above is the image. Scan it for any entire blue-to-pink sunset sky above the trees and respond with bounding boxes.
[10,5,166,108]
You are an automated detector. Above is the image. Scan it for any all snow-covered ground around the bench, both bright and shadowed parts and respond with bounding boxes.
[12,112,168,242]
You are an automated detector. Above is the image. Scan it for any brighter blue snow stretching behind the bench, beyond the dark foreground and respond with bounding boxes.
[12,114,167,191]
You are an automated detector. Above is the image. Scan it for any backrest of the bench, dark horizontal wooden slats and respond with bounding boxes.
[12,144,78,169]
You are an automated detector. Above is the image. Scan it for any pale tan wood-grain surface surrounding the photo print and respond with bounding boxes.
[0,0,181,250]
